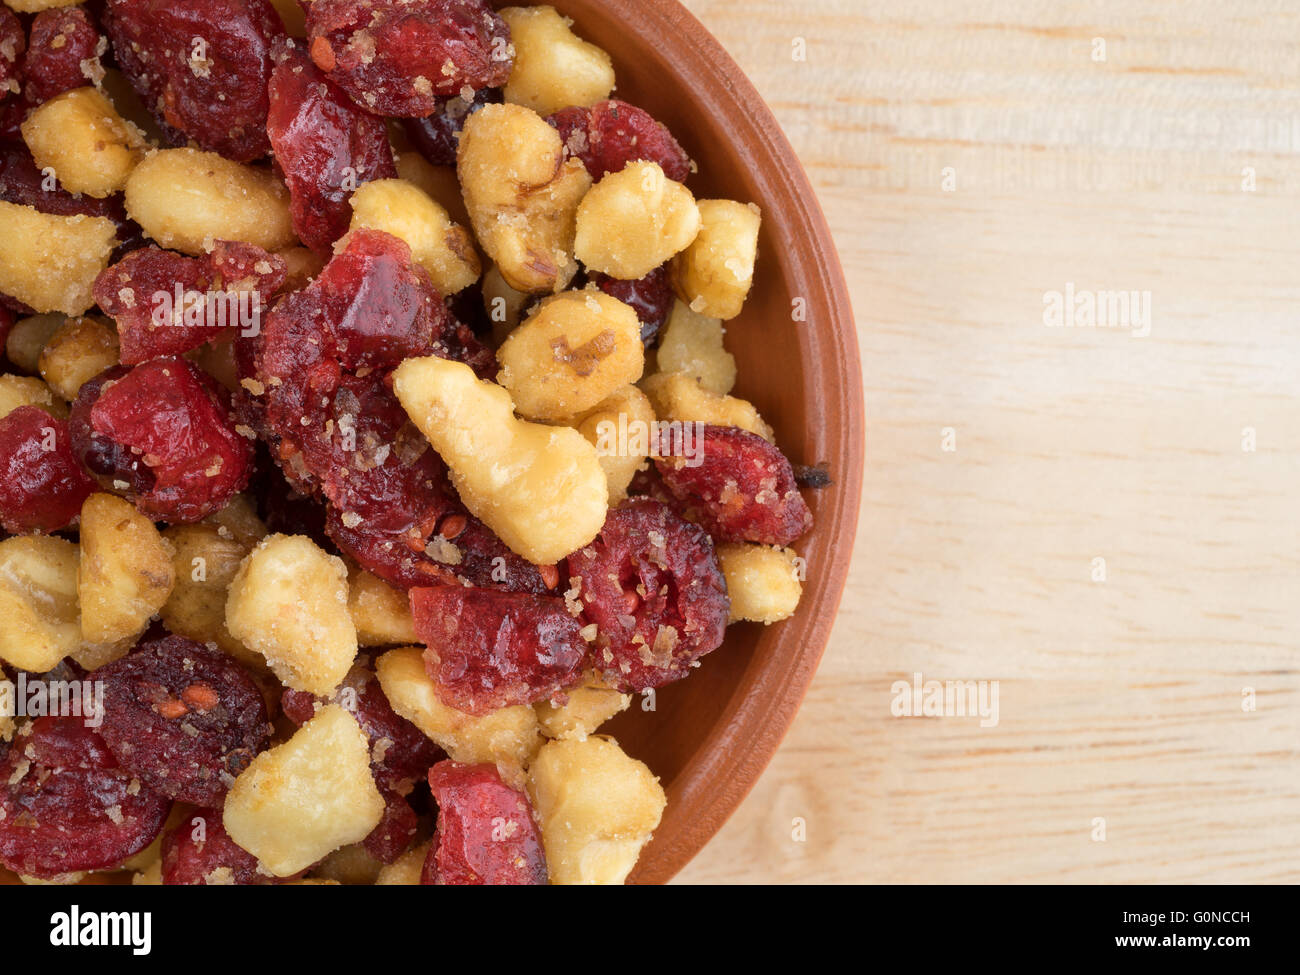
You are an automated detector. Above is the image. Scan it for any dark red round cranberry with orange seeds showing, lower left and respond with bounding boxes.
[95,637,270,807]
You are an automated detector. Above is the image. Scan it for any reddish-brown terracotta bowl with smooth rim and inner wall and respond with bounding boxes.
[0,0,863,884]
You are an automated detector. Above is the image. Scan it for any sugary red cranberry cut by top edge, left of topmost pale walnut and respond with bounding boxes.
[307,0,514,118]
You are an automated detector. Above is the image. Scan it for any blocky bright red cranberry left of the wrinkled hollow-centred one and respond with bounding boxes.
[411,586,588,715]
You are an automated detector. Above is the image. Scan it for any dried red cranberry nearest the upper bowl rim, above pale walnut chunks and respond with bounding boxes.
[546,99,690,183]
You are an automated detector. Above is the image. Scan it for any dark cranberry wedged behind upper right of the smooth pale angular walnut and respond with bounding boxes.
[280,663,442,796]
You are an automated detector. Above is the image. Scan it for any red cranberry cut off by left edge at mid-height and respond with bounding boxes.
[0,406,95,534]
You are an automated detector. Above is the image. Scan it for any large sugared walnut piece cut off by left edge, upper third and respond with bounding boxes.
[0,202,117,315]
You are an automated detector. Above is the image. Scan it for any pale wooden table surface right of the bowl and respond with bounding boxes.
[680,0,1300,883]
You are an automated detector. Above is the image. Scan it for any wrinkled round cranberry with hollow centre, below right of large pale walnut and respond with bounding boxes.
[568,498,731,692]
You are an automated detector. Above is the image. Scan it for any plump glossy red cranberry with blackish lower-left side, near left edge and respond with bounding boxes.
[69,356,252,523]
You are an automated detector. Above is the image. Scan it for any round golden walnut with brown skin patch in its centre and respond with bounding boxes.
[497,290,645,421]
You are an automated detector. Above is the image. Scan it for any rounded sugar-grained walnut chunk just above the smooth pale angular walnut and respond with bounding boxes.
[226,534,356,694]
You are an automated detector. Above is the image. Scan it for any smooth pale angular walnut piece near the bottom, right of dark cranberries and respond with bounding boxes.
[224,705,384,878]
